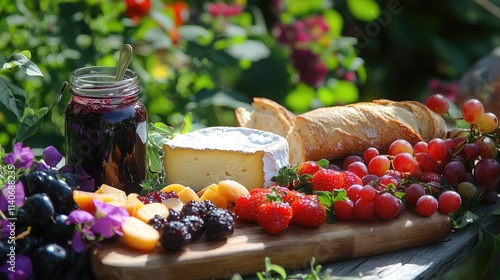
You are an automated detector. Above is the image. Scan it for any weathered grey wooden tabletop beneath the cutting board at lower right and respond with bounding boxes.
[252,197,500,280]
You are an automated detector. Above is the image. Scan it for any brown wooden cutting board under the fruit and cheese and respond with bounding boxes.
[92,209,451,280]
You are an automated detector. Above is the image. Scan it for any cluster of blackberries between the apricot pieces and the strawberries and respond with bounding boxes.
[148,200,234,252]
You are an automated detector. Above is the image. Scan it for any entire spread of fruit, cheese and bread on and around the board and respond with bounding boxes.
[0,72,500,279]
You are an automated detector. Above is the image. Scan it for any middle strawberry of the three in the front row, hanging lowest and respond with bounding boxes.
[257,202,293,235]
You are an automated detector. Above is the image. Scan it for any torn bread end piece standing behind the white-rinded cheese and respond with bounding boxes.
[235,97,295,137]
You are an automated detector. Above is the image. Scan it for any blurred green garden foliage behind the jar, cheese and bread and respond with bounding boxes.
[0,0,500,155]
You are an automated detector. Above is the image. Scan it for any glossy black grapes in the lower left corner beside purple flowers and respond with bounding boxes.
[0,171,91,279]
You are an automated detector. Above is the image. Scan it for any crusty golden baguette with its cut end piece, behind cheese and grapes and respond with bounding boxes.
[236,99,446,164]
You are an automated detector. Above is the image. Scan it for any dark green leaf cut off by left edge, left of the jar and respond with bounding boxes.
[0,77,26,120]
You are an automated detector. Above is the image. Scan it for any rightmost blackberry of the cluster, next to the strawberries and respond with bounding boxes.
[205,208,234,240]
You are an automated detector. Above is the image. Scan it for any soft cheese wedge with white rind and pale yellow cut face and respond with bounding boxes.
[163,126,288,191]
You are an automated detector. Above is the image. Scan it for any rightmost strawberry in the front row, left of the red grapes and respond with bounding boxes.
[291,198,326,228]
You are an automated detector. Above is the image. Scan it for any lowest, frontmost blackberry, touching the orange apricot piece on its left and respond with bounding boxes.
[160,221,191,252]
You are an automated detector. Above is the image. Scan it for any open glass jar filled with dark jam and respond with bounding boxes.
[65,66,147,194]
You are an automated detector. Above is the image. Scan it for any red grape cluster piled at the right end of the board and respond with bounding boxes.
[334,94,500,220]
